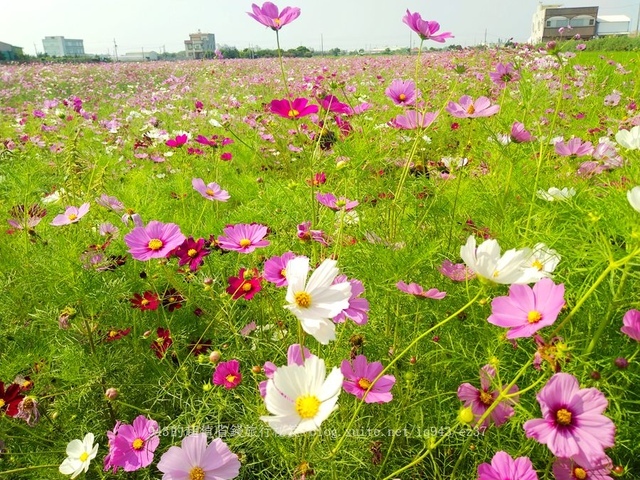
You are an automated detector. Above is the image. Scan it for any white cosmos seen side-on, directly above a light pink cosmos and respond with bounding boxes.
[460,235,546,285]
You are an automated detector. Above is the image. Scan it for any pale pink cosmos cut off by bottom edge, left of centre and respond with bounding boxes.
[158,433,240,480]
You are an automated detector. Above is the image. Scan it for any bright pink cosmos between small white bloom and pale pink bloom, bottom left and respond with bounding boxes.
[105,415,160,472]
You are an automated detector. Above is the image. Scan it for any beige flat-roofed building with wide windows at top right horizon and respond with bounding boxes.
[529,4,598,43]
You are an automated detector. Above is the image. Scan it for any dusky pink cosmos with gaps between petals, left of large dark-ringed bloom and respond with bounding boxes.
[458,365,518,430]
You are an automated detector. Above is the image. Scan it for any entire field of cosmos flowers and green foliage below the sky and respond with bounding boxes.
[0,2,640,480]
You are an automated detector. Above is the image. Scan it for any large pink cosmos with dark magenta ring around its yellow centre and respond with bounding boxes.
[524,373,616,463]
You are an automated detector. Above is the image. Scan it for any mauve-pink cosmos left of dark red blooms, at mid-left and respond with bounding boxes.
[124,220,186,262]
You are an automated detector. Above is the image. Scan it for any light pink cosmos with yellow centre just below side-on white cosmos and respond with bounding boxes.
[487,278,564,339]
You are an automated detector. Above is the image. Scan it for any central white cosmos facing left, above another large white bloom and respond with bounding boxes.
[284,257,351,345]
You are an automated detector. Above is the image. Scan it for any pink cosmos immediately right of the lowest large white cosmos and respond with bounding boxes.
[340,355,396,403]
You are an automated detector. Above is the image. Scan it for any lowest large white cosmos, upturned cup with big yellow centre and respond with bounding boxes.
[260,352,344,435]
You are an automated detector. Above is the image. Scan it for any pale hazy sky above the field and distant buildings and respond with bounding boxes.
[0,0,640,55]
